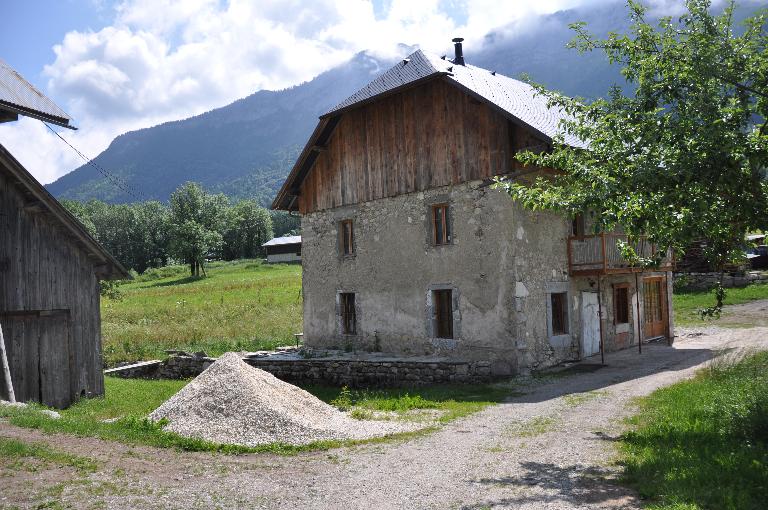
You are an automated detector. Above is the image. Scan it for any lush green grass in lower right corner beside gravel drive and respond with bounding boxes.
[620,352,768,510]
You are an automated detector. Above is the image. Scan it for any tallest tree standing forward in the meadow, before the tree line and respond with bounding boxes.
[170,182,229,276]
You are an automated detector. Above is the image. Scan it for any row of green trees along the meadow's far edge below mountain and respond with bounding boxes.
[62,182,300,275]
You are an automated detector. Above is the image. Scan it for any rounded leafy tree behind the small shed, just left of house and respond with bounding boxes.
[223,200,272,260]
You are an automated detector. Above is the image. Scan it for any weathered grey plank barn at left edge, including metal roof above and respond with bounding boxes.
[0,61,129,408]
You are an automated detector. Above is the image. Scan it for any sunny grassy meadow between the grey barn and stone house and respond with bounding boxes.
[101,260,302,366]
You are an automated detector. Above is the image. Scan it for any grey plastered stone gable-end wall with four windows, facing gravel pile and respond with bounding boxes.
[302,177,516,369]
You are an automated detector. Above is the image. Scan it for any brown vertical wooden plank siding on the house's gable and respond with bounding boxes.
[298,80,544,214]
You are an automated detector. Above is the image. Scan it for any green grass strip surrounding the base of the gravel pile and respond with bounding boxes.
[0,377,510,455]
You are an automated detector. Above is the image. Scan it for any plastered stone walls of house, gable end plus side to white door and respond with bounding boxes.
[302,181,608,373]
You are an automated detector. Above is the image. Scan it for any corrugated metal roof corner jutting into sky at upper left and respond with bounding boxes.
[0,60,73,128]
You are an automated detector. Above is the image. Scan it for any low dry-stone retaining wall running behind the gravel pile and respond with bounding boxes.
[107,356,494,388]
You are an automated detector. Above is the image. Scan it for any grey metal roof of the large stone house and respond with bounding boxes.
[324,50,586,147]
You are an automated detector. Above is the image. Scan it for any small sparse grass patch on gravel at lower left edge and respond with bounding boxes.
[0,437,97,473]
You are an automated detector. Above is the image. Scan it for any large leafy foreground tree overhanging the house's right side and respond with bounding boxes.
[501,0,768,310]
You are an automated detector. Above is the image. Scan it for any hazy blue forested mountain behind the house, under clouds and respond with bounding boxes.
[47,4,640,204]
